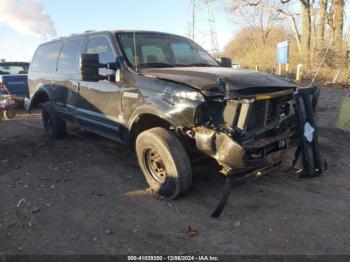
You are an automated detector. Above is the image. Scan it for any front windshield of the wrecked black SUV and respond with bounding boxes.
[117,32,219,68]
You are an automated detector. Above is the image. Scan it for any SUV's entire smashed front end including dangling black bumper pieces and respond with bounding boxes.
[193,88,322,217]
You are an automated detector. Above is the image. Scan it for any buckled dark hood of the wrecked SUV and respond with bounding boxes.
[140,67,295,95]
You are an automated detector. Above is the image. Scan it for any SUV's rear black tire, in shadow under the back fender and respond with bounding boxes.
[41,101,67,139]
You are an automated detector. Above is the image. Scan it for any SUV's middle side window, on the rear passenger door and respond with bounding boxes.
[57,38,83,73]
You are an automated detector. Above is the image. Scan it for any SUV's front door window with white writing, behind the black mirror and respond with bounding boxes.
[86,36,116,76]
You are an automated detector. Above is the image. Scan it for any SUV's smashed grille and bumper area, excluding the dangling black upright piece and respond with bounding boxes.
[194,89,297,175]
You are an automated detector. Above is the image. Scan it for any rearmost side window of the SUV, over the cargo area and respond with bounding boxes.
[30,42,62,72]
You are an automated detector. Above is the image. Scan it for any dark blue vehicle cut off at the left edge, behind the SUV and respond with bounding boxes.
[0,62,29,101]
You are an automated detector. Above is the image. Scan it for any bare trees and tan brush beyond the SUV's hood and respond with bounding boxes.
[225,0,350,75]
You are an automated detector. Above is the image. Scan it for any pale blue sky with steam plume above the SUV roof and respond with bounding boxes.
[0,0,235,61]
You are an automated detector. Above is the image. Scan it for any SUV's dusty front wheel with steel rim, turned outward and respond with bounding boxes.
[136,127,192,199]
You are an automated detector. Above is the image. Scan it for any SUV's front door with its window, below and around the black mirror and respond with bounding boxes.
[77,34,121,141]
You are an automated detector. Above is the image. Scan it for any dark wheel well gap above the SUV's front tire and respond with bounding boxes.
[130,114,171,148]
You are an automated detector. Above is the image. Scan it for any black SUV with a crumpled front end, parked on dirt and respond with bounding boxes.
[25,31,296,199]
